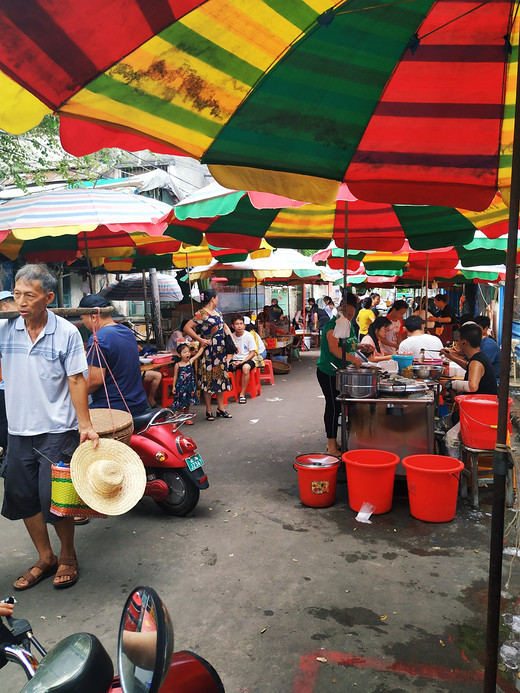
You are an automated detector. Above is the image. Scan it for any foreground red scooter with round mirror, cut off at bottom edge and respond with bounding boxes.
[0,587,225,693]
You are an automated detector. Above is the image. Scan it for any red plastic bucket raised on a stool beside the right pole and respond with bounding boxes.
[455,395,513,450]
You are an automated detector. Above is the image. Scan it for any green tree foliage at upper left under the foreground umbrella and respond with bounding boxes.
[0,115,121,191]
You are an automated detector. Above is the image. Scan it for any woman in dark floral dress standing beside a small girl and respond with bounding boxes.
[184,289,232,421]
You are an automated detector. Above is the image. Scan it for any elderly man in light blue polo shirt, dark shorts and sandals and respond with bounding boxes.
[0,265,99,590]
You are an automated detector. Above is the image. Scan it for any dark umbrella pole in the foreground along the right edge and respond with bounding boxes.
[484,79,520,693]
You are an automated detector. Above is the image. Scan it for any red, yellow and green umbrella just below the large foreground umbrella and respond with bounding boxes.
[170,186,509,253]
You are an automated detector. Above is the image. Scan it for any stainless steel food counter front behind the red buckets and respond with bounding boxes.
[338,390,435,476]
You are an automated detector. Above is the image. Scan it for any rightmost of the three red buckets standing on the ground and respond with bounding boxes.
[403,455,464,522]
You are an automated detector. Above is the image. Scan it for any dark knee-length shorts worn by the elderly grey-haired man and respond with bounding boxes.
[2,431,79,523]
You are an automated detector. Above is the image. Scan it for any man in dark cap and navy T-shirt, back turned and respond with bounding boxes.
[79,294,149,416]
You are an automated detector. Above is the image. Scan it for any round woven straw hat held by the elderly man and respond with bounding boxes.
[70,438,146,515]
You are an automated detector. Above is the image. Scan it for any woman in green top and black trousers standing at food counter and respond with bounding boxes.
[316,294,361,455]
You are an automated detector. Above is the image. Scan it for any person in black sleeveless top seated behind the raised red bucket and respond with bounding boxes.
[441,322,498,459]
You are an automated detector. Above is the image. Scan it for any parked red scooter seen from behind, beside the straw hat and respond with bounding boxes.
[129,408,209,517]
